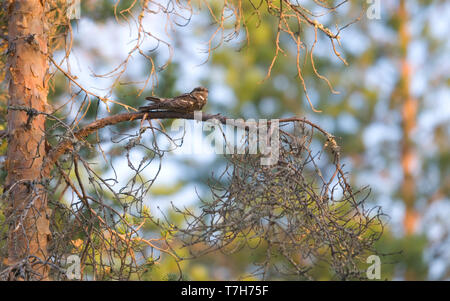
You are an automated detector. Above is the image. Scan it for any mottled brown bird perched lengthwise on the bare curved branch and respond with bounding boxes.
[139,87,208,113]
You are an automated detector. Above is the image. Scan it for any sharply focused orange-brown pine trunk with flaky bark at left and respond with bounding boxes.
[5,0,50,279]
